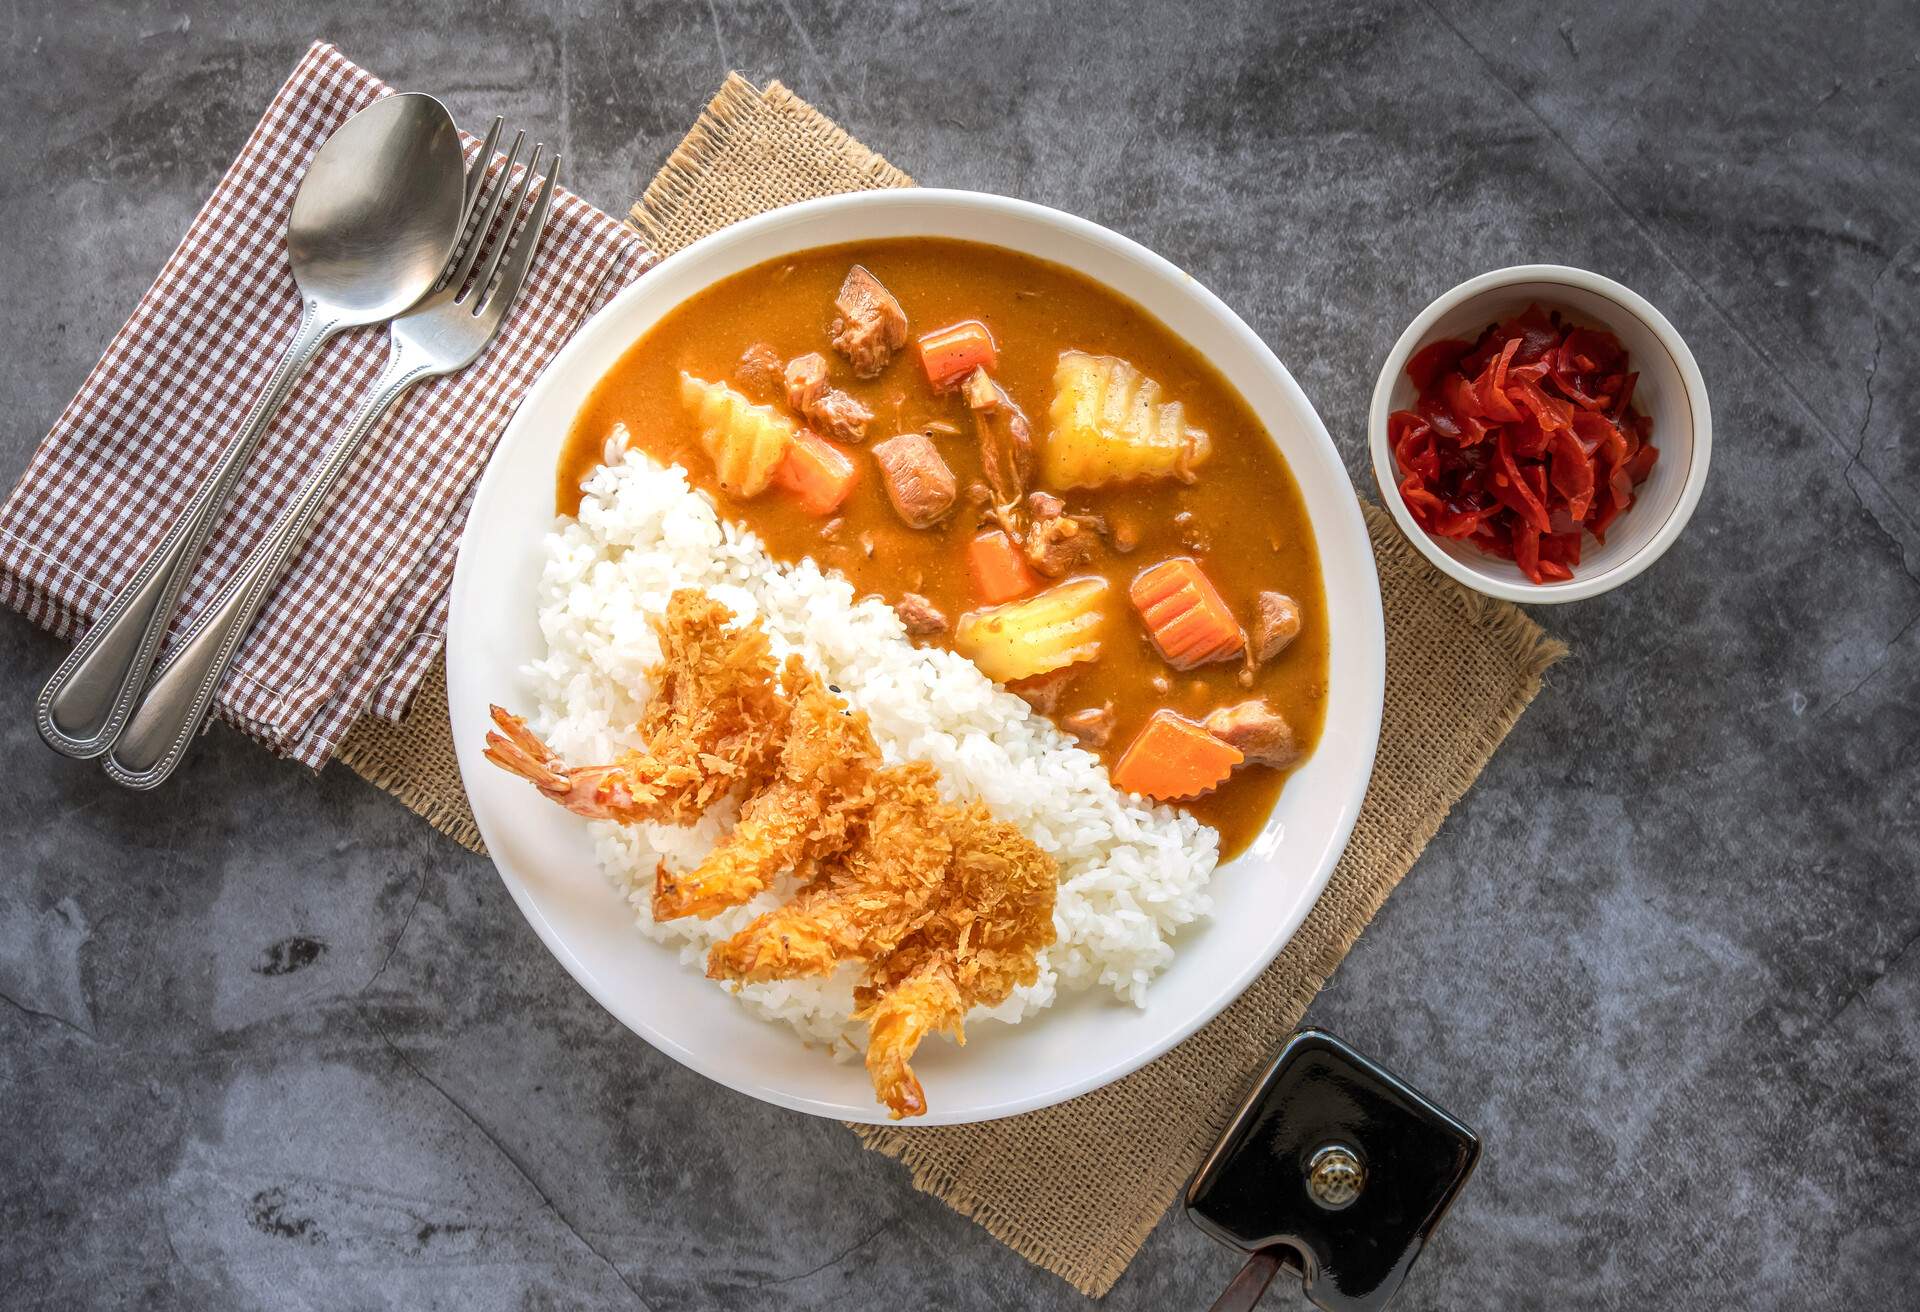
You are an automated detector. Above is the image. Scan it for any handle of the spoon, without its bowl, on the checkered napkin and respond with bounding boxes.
[33,300,344,761]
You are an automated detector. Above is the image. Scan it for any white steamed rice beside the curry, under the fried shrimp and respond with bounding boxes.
[528,451,1219,1053]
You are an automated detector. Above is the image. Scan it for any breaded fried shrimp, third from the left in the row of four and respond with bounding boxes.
[707,761,954,984]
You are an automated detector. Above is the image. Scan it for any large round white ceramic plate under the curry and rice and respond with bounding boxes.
[447,188,1386,1124]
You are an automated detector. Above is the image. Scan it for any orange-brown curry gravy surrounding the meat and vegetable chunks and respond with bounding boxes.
[557,238,1327,859]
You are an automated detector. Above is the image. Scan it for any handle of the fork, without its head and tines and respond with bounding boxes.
[104,346,444,790]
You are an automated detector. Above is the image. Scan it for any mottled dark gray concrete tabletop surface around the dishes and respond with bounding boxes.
[0,0,1920,1310]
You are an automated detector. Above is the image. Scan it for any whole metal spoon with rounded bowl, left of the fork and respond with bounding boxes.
[35,94,470,759]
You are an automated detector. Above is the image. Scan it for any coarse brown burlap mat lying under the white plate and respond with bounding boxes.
[340,75,1567,1295]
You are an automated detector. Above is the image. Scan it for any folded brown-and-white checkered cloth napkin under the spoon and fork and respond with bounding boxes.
[0,44,653,768]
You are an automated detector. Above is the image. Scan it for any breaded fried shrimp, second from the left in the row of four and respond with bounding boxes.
[653,657,879,920]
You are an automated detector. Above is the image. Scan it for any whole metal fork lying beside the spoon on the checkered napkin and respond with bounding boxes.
[106,133,561,790]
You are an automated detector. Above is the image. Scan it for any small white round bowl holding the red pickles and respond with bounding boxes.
[1367,265,1713,603]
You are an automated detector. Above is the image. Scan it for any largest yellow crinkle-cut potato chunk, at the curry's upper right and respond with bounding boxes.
[1044,352,1212,488]
